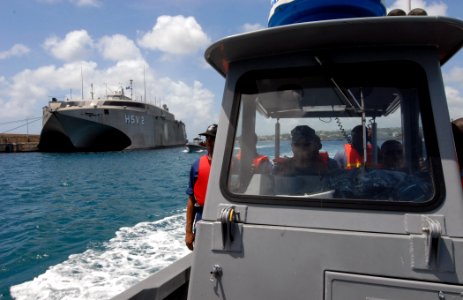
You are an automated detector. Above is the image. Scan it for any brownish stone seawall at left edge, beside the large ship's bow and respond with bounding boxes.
[0,133,40,152]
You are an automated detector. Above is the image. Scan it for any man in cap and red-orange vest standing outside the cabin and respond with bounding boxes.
[185,124,217,250]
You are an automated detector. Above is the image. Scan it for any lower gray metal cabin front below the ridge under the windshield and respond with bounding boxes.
[189,222,463,300]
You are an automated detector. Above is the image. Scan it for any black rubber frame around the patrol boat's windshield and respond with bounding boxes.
[220,60,445,212]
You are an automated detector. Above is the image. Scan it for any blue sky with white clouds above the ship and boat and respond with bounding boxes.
[0,0,463,140]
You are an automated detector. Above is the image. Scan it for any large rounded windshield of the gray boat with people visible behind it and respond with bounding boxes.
[227,61,442,208]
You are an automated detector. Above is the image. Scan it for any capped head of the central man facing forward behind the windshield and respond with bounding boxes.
[291,125,322,158]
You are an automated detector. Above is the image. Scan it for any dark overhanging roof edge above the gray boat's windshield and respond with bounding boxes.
[205,16,463,76]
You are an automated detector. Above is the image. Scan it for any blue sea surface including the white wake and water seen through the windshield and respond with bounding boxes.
[0,141,342,300]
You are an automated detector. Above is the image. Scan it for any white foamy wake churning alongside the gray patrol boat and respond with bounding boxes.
[10,213,189,300]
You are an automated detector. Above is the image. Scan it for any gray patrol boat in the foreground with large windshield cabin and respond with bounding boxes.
[113,1,463,300]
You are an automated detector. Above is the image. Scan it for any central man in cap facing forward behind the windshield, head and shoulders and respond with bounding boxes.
[273,125,339,176]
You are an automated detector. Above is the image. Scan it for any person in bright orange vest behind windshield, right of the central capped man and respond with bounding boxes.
[334,125,373,170]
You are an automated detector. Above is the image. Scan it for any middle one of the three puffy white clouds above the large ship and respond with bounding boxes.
[98,34,142,61]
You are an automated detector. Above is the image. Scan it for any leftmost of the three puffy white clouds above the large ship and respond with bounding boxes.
[43,30,93,61]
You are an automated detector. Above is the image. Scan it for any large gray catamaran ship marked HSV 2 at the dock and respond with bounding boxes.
[38,93,186,152]
